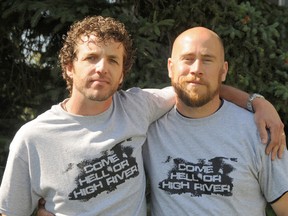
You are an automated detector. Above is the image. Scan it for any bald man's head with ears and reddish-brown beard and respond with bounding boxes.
[168,31,228,107]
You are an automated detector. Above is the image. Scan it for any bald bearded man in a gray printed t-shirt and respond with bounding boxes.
[144,27,288,216]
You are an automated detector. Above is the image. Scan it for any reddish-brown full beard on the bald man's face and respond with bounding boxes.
[171,76,222,108]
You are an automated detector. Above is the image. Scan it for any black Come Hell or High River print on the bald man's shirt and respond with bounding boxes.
[159,157,237,197]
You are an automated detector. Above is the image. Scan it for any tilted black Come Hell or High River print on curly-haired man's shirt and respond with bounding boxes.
[69,140,139,201]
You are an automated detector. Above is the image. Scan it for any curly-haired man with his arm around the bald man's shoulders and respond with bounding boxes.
[0,16,283,216]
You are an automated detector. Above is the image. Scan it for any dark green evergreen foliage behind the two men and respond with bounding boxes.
[0,0,288,215]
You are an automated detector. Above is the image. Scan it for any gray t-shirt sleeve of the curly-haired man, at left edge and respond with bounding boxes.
[0,127,37,216]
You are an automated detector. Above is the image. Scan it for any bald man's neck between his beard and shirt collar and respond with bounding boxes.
[176,95,222,119]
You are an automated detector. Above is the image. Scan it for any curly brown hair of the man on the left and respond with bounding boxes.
[59,16,135,95]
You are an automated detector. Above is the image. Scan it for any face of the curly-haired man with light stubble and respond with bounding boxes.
[67,35,124,101]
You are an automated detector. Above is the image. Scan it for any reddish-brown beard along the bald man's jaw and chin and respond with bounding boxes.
[172,82,221,107]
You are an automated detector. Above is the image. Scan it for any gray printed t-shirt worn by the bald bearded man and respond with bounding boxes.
[143,101,288,216]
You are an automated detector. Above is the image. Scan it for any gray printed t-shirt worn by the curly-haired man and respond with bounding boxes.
[0,88,174,216]
